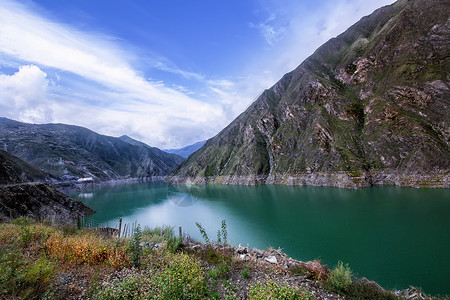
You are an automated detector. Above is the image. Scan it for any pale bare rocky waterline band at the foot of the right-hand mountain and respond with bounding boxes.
[166,170,450,189]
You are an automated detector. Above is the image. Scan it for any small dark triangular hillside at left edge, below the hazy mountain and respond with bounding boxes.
[0,150,49,184]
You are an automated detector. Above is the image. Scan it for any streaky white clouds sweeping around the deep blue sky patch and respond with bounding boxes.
[0,0,393,148]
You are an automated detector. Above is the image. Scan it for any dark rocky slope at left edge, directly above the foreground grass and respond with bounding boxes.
[0,183,94,223]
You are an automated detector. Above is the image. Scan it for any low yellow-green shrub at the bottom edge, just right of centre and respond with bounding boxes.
[249,280,314,300]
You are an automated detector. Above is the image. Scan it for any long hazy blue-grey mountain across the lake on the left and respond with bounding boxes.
[0,118,183,180]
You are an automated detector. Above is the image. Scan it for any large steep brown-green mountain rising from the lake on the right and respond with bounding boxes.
[171,0,450,188]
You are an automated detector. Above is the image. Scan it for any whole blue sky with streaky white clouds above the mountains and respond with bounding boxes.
[0,0,394,149]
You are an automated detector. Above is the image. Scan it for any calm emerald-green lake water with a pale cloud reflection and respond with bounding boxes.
[71,183,450,294]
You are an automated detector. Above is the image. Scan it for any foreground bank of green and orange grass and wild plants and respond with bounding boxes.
[0,218,424,299]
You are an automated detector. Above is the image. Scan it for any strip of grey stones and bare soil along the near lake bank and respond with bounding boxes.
[183,239,433,299]
